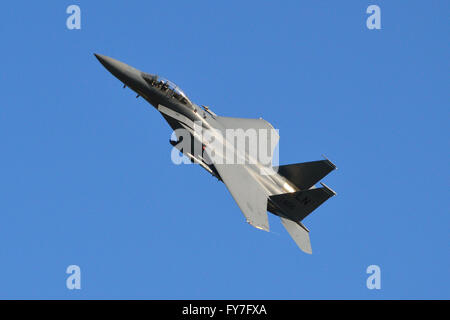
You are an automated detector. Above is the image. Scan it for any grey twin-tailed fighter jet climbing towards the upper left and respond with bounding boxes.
[94,54,336,254]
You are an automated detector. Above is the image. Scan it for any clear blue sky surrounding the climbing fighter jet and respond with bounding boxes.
[0,0,450,299]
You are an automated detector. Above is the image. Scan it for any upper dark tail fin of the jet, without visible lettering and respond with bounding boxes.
[274,159,336,190]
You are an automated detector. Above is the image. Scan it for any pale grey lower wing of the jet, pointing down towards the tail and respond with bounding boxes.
[214,164,269,231]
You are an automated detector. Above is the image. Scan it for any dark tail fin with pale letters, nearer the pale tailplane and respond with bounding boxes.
[270,183,336,221]
